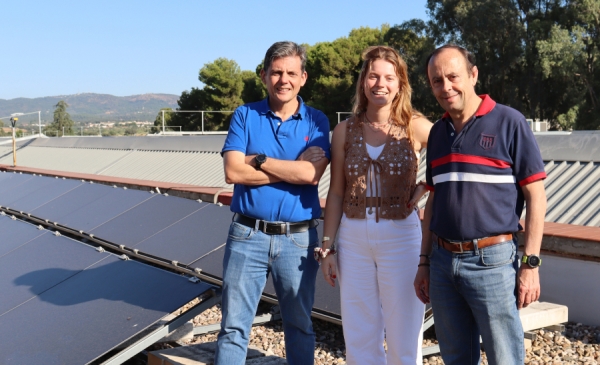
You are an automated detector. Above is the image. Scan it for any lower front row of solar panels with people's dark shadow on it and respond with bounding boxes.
[0,216,209,365]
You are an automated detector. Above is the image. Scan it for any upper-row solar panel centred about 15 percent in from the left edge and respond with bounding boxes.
[31,183,153,232]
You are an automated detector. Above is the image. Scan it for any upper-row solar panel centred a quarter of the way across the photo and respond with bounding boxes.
[91,195,203,247]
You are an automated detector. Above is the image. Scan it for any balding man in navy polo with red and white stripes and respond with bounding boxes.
[415,45,546,365]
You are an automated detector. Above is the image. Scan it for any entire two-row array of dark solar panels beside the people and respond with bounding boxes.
[0,172,340,363]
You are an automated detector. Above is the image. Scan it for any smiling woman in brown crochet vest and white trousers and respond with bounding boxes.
[318,46,431,365]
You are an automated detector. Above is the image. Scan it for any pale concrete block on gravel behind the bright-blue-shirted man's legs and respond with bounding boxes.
[148,342,287,365]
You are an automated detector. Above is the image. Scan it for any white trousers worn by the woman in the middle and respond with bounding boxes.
[338,211,425,365]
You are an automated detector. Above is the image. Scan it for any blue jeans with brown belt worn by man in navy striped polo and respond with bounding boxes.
[429,237,525,365]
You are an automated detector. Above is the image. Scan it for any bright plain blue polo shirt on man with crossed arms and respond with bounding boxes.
[222,97,331,222]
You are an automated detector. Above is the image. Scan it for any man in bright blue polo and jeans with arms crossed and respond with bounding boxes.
[215,42,330,365]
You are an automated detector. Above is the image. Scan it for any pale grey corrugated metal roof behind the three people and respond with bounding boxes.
[0,131,600,226]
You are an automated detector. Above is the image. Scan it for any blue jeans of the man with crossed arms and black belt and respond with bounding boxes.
[215,222,319,365]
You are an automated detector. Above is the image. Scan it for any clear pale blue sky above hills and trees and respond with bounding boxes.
[0,0,427,99]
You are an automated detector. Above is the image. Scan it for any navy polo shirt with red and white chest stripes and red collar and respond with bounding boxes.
[426,95,546,241]
